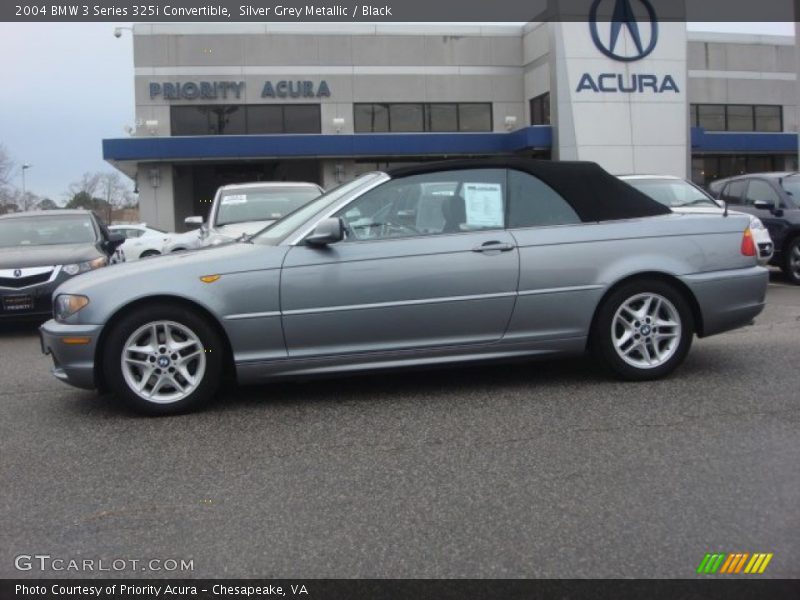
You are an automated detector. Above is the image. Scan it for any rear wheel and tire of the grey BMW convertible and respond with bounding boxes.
[591,279,694,381]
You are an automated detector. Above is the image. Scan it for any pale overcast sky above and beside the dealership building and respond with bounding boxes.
[0,23,794,202]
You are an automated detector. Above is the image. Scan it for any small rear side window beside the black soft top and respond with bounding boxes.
[508,169,581,228]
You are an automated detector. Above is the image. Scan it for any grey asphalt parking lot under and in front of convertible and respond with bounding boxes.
[0,275,800,578]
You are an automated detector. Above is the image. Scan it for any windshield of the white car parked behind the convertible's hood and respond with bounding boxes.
[216,185,320,226]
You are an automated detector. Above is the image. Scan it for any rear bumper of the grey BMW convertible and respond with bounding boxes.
[681,267,769,337]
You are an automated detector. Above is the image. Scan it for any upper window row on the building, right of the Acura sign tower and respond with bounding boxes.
[689,104,783,132]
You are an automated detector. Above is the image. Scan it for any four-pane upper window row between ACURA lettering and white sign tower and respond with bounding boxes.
[353,102,492,133]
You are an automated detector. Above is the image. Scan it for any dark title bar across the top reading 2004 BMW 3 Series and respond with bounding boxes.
[0,0,800,23]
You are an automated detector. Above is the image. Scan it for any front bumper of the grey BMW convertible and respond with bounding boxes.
[39,319,102,390]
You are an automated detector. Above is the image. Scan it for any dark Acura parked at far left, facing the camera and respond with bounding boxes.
[0,210,122,319]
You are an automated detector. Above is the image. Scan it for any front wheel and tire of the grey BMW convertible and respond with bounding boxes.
[103,303,223,415]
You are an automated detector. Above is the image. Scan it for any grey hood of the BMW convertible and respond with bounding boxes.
[57,238,288,299]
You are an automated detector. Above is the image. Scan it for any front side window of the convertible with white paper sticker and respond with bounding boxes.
[336,169,506,241]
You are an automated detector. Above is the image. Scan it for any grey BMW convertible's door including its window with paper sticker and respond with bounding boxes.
[281,169,519,357]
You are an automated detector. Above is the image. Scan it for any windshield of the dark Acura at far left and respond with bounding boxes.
[0,215,97,248]
